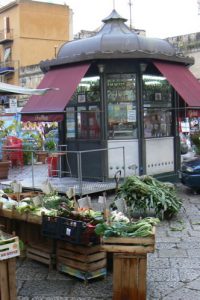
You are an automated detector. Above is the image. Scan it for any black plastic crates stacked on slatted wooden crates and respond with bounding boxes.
[42,215,106,280]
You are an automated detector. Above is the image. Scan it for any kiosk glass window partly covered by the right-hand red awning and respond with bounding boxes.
[143,75,172,138]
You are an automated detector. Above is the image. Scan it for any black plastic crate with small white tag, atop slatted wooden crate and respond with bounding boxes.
[58,218,100,245]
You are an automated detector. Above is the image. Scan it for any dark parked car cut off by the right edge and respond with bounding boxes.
[179,157,200,191]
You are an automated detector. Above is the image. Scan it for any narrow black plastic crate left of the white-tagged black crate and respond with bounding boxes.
[41,215,60,239]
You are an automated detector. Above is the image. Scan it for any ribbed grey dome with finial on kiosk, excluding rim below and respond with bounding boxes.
[57,10,175,58]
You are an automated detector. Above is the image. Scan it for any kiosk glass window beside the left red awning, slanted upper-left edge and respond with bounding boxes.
[66,76,100,139]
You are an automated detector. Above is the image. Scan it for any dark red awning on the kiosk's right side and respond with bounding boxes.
[154,62,200,107]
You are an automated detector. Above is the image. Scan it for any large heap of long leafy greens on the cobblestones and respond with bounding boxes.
[117,175,182,219]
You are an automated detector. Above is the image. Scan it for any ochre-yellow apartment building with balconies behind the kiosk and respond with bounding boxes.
[0,0,72,110]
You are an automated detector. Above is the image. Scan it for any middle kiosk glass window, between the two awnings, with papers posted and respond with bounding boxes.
[107,74,137,139]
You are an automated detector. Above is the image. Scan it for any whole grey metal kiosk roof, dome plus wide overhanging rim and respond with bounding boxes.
[41,10,191,69]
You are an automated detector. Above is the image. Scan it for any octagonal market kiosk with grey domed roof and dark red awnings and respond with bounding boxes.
[22,10,200,180]
